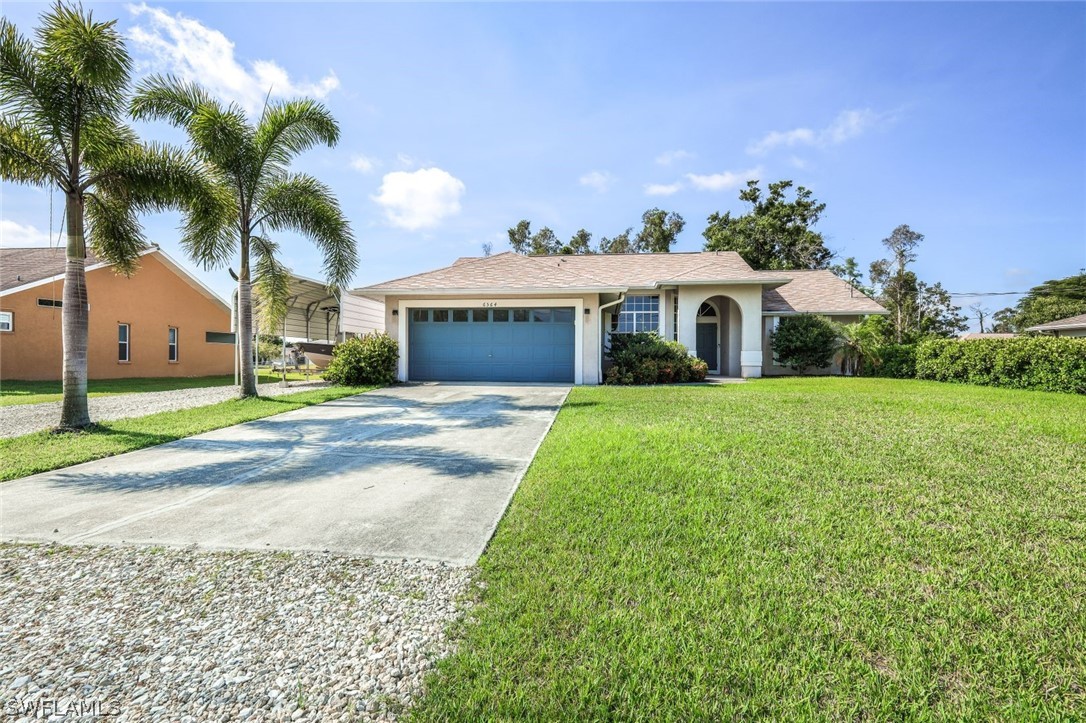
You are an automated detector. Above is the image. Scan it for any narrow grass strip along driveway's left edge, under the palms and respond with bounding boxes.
[0,386,372,482]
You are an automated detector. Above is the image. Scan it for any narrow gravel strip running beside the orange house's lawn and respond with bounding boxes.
[0,381,328,437]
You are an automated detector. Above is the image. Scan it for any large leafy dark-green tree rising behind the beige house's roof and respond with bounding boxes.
[703,180,833,270]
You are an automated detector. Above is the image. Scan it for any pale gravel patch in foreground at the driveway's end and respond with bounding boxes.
[0,544,471,722]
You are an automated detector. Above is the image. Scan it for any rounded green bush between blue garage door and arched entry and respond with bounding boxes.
[604,332,709,384]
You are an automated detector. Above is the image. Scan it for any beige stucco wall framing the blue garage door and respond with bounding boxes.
[384,292,601,384]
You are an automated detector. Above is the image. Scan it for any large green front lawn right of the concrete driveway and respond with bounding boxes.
[415,379,1086,721]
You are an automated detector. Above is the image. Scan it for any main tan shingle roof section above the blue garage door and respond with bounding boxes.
[355,251,788,295]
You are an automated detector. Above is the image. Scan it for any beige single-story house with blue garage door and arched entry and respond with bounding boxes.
[353,252,886,384]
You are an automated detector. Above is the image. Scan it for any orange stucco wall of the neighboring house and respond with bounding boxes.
[0,254,233,380]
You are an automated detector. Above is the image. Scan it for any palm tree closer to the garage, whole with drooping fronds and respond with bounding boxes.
[131,76,358,397]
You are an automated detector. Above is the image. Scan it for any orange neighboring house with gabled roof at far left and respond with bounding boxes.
[0,249,233,380]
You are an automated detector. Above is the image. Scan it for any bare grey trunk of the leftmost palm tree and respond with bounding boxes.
[61,194,90,429]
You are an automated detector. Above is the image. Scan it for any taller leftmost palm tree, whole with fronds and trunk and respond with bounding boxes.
[0,2,215,429]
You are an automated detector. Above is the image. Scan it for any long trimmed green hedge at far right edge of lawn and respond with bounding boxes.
[917,337,1086,394]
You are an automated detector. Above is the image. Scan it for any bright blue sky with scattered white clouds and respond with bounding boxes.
[2,2,1086,323]
